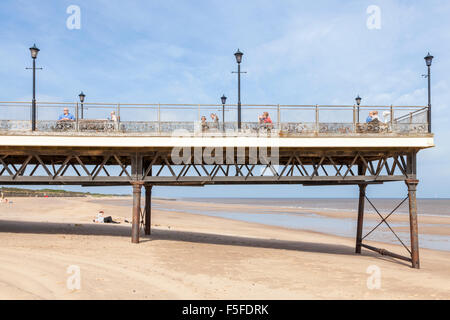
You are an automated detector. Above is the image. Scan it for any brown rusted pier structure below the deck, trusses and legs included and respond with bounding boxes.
[0,136,432,268]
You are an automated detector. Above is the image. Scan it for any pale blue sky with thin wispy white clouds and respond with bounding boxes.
[0,0,450,198]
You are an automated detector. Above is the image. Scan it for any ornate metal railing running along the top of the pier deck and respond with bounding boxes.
[0,102,428,136]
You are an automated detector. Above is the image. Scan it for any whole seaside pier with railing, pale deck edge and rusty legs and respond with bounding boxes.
[0,102,434,268]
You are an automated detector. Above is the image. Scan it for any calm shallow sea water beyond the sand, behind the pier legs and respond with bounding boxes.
[92,198,450,251]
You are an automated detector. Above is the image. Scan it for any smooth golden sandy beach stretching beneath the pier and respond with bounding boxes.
[0,198,450,299]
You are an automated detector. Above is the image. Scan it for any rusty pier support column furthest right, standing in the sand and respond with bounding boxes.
[405,179,420,269]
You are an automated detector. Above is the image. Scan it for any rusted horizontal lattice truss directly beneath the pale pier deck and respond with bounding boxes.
[0,148,415,185]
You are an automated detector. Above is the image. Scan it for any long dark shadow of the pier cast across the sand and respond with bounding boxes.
[0,220,409,266]
